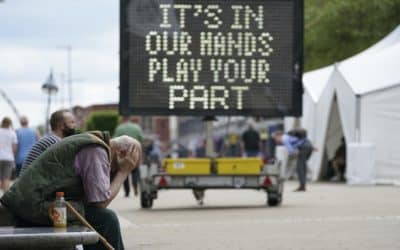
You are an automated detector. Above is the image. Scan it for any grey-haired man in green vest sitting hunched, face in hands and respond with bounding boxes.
[0,132,142,249]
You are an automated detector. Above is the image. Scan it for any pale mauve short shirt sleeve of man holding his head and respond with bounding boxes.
[74,145,111,203]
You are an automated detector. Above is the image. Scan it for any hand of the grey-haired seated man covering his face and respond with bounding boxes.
[117,144,142,172]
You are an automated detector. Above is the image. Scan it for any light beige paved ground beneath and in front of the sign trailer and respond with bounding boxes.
[112,183,400,250]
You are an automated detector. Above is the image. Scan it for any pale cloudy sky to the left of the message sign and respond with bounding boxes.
[0,0,119,128]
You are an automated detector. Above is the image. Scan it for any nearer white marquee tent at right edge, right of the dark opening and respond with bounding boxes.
[333,42,400,184]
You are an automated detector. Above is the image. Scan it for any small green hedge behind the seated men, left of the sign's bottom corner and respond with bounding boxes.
[86,111,119,135]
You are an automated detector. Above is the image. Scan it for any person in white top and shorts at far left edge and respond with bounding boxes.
[0,117,18,191]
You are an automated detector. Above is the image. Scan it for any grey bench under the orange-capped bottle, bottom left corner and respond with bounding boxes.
[0,226,99,250]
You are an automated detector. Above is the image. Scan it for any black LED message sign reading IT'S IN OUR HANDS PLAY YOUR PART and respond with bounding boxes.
[120,0,303,117]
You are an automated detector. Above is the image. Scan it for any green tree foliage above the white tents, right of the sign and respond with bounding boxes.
[304,0,400,70]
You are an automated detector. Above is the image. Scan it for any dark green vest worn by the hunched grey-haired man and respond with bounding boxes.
[1,133,110,226]
